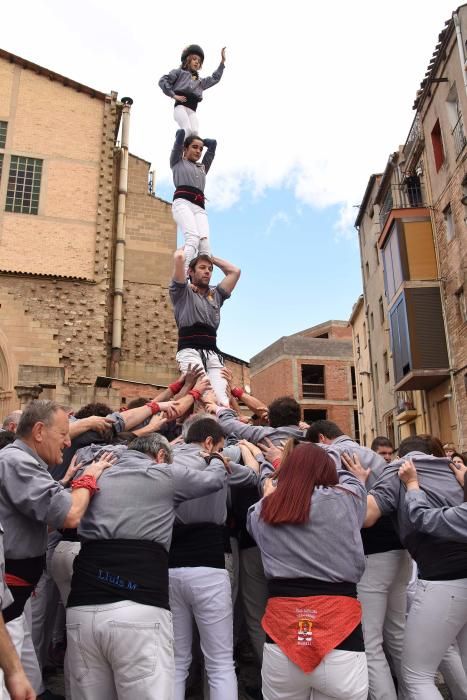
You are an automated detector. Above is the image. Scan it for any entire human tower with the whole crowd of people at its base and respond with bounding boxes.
[0,45,467,700]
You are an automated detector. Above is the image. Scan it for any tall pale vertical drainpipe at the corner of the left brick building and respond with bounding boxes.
[110,97,133,377]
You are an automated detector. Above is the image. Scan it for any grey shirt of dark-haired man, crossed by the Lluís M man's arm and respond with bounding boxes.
[174,443,258,525]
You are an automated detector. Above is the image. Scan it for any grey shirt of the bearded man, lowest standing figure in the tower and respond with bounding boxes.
[169,280,230,329]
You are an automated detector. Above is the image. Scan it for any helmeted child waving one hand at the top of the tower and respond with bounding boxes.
[159,44,225,136]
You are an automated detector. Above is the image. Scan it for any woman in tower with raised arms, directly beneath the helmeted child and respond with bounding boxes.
[170,129,217,269]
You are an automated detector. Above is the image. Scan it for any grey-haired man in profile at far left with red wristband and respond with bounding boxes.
[0,400,111,697]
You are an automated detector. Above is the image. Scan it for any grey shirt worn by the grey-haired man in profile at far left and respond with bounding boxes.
[0,439,72,559]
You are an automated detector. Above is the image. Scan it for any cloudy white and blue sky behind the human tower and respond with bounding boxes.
[0,0,456,360]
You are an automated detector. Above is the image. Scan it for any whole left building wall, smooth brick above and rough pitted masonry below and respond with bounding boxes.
[0,59,118,406]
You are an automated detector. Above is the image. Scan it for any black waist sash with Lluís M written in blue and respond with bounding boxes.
[67,539,170,610]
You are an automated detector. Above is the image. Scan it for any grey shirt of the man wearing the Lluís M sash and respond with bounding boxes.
[78,450,227,551]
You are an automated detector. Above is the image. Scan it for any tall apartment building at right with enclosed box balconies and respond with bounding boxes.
[351,5,467,449]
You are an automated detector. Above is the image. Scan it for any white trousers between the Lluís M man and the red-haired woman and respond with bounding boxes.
[169,566,238,700]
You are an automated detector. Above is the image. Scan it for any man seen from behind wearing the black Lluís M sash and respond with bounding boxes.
[67,433,227,700]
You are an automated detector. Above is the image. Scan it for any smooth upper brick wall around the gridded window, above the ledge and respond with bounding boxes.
[0,59,115,279]
